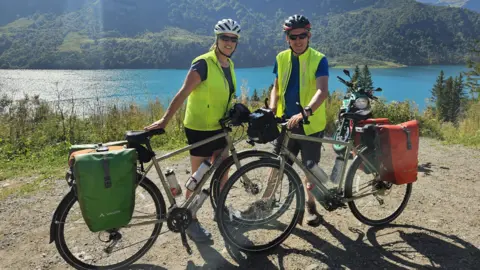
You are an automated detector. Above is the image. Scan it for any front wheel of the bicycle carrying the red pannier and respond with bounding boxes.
[216,158,305,252]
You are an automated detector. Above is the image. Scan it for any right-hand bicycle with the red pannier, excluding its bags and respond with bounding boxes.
[216,103,412,252]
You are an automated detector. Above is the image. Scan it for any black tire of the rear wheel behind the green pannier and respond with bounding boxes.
[54,175,166,269]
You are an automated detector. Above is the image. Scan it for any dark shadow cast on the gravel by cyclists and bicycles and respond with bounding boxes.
[129,222,480,270]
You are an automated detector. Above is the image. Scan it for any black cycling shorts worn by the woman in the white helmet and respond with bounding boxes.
[185,128,227,157]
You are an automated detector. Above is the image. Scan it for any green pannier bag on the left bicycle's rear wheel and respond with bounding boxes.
[73,147,137,232]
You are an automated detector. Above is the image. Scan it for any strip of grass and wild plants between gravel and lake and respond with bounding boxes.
[0,78,480,199]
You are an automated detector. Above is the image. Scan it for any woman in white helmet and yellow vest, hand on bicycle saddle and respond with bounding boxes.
[145,19,241,242]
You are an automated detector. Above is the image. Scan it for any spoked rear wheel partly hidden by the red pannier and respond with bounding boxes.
[345,149,412,226]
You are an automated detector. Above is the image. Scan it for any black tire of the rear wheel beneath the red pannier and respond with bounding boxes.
[345,148,412,226]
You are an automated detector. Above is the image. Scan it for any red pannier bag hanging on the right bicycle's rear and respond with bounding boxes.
[376,120,419,185]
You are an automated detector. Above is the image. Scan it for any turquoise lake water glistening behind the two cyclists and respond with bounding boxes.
[0,66,467,110]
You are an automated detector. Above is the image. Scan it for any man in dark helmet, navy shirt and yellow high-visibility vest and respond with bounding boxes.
[269,15,329,226]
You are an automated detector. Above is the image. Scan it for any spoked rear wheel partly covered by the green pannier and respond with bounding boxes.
[51,175,166,269]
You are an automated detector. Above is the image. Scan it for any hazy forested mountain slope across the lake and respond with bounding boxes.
[0,0,480,69]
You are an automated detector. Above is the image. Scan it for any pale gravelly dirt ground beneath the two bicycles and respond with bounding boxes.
[0,138,480,269]
